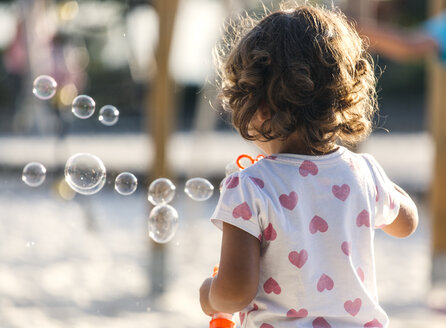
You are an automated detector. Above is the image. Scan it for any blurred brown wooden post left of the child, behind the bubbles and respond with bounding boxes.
[146,0,178,296]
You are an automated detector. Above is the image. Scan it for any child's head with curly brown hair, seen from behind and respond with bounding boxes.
[217,5,376,152]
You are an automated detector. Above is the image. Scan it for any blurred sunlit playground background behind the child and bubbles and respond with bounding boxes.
[0,0,446,328]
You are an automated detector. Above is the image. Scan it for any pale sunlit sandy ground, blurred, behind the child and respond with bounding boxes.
[0,132,446,328]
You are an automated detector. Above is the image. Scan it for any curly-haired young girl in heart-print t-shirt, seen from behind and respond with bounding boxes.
[200,5,418,328]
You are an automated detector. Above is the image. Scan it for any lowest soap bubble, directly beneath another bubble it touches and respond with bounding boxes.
[148,204,178,244]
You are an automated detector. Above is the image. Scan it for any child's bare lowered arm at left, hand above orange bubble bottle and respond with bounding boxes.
[200,223,260,315]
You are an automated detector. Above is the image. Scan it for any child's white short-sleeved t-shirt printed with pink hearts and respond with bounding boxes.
[211,147,400,328]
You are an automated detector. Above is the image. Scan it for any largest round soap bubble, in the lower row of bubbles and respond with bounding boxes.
[65,153,106,195]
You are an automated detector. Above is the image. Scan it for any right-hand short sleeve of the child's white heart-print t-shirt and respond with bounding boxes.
[362,154,400,229]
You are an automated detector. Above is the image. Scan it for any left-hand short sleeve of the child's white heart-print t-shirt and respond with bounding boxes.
[211,172,263,239]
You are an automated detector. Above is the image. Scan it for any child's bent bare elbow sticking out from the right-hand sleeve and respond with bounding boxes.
[382,185,418,238]
